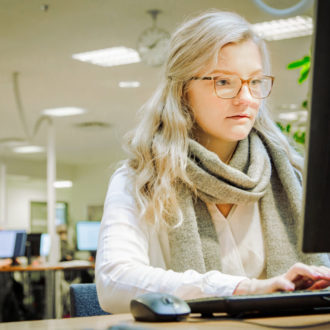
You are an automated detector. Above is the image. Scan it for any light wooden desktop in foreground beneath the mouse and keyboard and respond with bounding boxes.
[0,314,330,330]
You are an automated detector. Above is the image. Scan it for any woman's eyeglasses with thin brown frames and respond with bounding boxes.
[191,74,274,99]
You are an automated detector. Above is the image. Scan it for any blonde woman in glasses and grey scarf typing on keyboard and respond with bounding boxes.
[96,11,330,313]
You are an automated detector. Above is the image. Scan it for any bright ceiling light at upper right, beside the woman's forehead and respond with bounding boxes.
[252,16,313,41]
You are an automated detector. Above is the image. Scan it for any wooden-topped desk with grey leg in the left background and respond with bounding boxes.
[0,260,95,318]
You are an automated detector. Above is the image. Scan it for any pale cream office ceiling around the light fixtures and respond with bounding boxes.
[0,0,312,164]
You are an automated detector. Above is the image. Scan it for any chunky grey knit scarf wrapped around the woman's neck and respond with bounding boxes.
[169,130,328,278]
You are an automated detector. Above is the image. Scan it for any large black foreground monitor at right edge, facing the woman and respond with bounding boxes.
[302,0,330,253]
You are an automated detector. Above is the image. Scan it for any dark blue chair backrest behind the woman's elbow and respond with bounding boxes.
[70,283,109,317]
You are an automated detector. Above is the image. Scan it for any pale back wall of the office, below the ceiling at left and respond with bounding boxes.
[3,161,116,230]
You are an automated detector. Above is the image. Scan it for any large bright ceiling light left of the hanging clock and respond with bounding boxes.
[72,46,141,67]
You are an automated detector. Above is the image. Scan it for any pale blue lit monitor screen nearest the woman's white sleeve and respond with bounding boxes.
[76,221,101,251]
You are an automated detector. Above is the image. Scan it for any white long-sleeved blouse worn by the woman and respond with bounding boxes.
[95,166,265,313]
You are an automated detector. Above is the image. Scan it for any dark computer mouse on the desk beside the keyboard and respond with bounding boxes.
[131,293,190,322]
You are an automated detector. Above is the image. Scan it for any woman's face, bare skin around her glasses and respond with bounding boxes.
[187,40,263,146]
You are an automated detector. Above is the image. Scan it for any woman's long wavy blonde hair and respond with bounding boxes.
[125,10,301,224]
